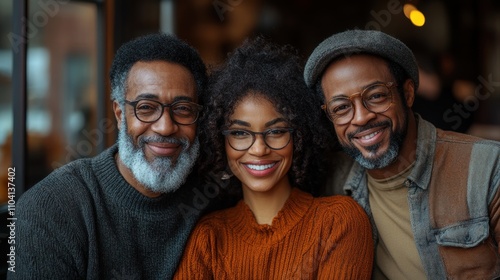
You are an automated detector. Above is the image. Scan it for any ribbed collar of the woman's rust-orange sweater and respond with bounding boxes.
[227,188,313,244]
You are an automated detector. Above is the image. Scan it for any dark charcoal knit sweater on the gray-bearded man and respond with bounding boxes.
[8,146,207,279]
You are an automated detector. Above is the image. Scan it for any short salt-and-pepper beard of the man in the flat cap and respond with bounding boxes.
[341,120,407,169]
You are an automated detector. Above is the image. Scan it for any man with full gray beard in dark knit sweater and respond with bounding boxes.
[8,34,208,279]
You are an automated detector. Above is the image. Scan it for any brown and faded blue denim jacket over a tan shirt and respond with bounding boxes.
[329,115,500,279]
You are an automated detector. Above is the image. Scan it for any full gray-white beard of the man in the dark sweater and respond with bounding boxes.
[118,118,200,193]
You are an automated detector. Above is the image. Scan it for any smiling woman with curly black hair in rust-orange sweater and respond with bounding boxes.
[175,37,374,279]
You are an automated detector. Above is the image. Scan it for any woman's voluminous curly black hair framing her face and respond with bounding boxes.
[199,36,332,195]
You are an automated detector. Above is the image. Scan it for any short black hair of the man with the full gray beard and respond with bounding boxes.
[109,33,207,104]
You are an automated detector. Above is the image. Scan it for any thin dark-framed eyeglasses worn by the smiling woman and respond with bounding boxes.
[222,128,293,151]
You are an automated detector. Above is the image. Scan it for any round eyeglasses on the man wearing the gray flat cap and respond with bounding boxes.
[321,82,396,125]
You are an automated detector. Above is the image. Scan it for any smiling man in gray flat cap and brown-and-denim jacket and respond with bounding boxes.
[304,30,500,279]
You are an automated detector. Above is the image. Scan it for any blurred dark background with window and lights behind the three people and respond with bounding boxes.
[0,0,500,276]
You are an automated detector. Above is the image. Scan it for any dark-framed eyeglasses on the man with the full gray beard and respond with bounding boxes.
[125,99,203,125]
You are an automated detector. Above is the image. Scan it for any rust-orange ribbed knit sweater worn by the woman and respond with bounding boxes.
[174,188,374,280]
